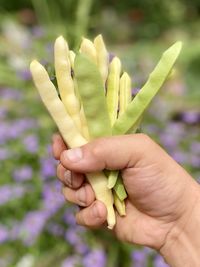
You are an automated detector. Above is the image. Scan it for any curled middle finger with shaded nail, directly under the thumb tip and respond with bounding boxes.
[57,164,85,189]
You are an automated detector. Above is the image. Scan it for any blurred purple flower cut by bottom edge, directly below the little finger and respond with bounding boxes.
[83,249,106,267]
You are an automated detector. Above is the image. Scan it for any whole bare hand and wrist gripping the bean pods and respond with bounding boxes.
[53,134,200,267]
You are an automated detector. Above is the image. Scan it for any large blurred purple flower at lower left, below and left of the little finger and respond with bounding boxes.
[19,210,48,246]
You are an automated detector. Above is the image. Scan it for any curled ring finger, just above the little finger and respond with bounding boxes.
[62,183,95,207]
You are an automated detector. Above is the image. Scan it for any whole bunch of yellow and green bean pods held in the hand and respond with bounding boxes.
[30,35,182,229]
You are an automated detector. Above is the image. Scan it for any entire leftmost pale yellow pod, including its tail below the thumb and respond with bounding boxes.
[30,60,115,229]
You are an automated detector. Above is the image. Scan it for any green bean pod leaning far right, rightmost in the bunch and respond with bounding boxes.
[113,42,182,135]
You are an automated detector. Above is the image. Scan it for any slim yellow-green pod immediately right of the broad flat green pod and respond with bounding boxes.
[106,57,121,126]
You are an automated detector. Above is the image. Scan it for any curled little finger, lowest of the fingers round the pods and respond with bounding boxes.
[76,200,107,228]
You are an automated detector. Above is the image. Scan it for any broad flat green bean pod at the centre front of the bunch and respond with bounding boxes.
[74,54,112,139]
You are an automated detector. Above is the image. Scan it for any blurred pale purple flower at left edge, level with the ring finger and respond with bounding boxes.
[0,184,27,206]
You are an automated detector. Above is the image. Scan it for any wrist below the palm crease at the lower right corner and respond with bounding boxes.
[160,182,200,267]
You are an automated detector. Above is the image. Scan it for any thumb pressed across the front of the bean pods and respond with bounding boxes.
[60,134,154,173]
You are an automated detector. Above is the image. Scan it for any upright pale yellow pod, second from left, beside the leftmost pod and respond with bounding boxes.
[54,36,81,132]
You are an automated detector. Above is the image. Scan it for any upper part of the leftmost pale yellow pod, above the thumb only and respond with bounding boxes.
[30,60,87,147]
